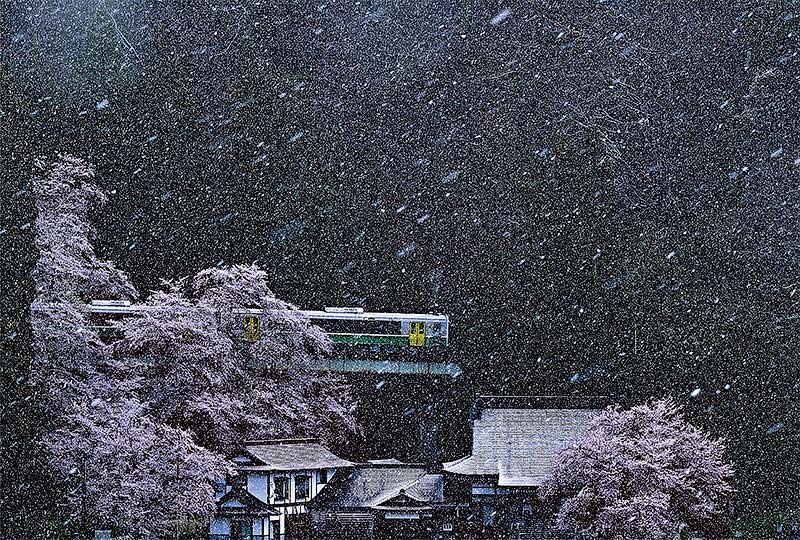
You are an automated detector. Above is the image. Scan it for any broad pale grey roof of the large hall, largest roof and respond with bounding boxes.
[444,408,597,486]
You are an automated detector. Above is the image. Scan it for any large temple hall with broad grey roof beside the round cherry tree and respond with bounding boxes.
[443,397,605,539]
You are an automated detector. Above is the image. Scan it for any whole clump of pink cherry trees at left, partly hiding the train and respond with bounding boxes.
[32,156,356,537]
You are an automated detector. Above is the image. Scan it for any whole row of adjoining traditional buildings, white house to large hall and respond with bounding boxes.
[210,396,608,540]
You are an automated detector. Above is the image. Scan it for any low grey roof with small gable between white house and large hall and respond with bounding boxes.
[313,464,443,508]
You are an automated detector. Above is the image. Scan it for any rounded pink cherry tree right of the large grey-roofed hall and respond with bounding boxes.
[542,400,733,540]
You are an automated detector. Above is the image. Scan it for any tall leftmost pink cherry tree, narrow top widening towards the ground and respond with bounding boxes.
[32,156,229,535]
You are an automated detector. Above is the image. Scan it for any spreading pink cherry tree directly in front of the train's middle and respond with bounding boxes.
[115,266,355,451]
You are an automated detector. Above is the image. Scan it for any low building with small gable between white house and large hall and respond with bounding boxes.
[310,459,444,540]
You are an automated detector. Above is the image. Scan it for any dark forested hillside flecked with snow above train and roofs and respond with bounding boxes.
[9,0,800,524]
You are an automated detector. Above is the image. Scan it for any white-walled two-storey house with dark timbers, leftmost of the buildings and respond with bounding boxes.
[209,439,353,540]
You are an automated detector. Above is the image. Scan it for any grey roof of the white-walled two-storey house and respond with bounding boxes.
[234,439,353,471]
